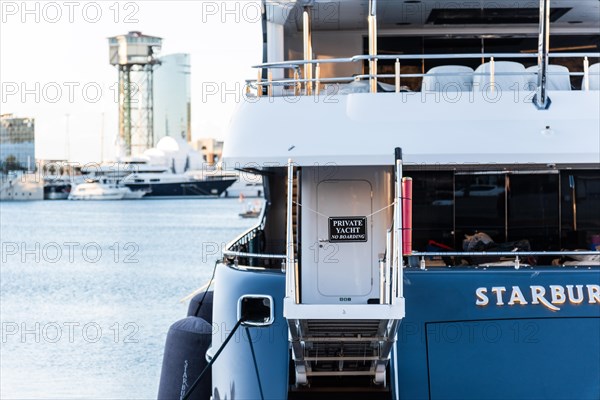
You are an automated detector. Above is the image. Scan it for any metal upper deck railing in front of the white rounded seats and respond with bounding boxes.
[246,52,600,97]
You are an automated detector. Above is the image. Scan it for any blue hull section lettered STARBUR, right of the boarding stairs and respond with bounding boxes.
[397,267,600,399]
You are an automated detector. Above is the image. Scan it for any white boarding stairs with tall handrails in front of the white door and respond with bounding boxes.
[283,152,404,385]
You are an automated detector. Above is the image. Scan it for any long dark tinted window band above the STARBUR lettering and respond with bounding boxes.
[407,171,600,251]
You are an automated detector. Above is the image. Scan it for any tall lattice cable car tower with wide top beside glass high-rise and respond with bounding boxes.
[108,31,162,156]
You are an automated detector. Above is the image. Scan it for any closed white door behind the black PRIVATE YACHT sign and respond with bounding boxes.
[315,180,374,302]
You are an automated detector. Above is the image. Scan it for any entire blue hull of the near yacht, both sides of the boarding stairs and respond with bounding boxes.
[209,265,600,399]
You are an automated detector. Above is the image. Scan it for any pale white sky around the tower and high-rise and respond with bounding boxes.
[0,0,262,162]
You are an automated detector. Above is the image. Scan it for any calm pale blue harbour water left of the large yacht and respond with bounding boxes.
[0,199,256,399]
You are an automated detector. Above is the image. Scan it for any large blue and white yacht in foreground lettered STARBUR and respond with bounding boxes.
[158,0,600,400]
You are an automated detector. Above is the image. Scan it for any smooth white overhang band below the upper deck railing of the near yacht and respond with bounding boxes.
[225,90,600,167]
